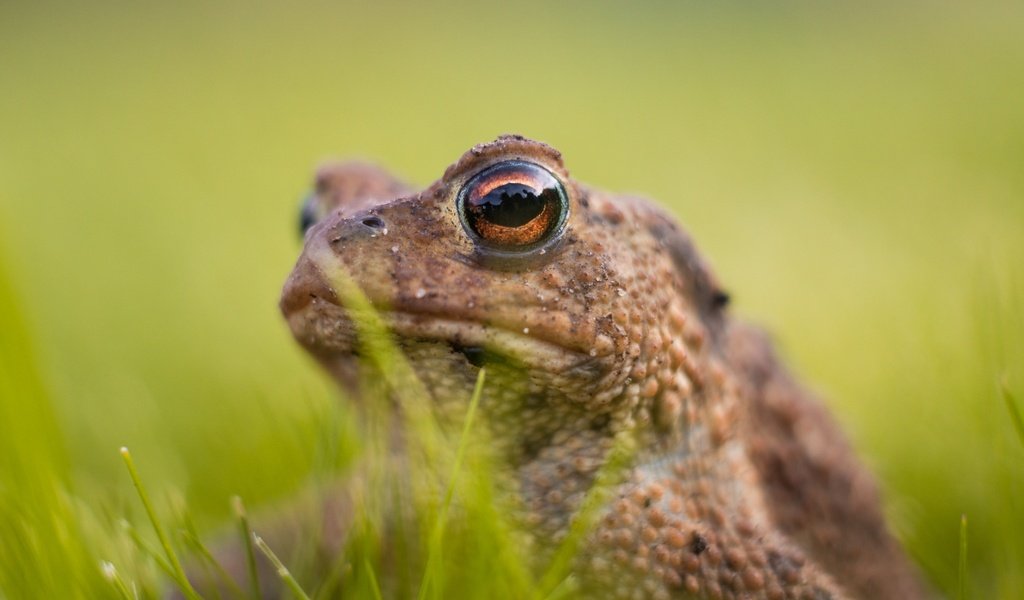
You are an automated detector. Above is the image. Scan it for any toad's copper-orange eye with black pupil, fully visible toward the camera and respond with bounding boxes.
[458,161,569,252]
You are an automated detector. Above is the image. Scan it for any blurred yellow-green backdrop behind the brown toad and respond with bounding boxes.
[0,2,1024,598]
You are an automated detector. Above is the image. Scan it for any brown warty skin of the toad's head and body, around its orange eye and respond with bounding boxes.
[281,136,924,599]
